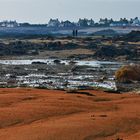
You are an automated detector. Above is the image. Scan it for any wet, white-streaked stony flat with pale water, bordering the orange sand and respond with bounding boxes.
[0,59,124,90]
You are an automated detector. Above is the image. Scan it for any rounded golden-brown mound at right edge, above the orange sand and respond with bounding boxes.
[115,65,140,83]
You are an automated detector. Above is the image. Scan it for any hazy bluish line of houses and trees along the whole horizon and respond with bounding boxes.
[0,17,140,28]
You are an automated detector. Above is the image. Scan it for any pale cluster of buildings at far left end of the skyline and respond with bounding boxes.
[0,21,19,28]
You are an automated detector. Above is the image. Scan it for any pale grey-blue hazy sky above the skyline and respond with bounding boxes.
[0,0,140,23]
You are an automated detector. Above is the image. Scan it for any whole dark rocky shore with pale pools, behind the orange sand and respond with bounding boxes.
[0,31,140,91]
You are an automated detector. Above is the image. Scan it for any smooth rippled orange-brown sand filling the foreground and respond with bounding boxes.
[0,89,140,140]
